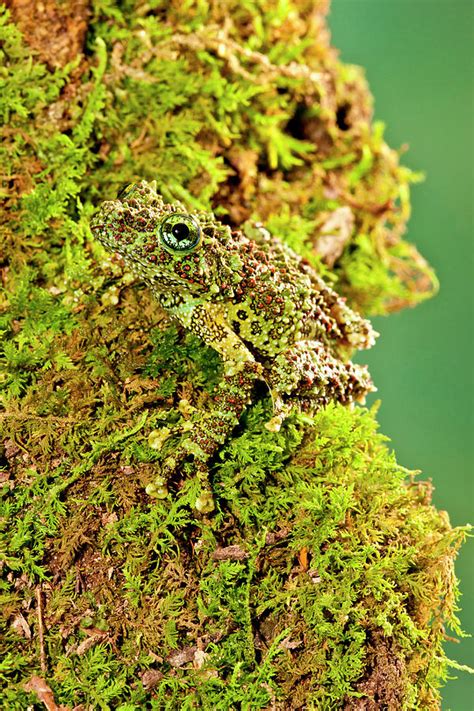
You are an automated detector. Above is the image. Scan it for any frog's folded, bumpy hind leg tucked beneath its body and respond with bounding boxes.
[266,341,375,431]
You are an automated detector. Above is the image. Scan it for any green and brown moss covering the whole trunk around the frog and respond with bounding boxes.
[0,0,467,711]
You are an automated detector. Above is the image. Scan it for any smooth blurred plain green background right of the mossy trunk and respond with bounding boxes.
[329,0,474,711]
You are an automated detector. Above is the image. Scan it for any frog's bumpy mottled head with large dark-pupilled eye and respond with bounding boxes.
[91,181,240,296]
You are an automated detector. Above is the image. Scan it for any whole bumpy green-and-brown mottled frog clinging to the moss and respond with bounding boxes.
[91,181,377,512]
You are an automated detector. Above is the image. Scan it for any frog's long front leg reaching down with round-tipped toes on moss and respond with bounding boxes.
[147,303,263,513]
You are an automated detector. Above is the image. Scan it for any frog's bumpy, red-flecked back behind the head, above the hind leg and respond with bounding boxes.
[228,228,375,358]
